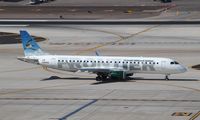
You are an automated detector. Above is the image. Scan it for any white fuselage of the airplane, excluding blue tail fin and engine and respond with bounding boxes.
[25,55,187,75]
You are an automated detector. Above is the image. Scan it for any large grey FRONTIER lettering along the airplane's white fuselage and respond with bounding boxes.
[54,59,156,71]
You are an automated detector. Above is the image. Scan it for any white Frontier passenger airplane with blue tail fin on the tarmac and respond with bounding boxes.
[18,30,187,81]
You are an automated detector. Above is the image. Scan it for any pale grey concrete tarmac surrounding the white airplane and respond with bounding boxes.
[0,25,200,120]
